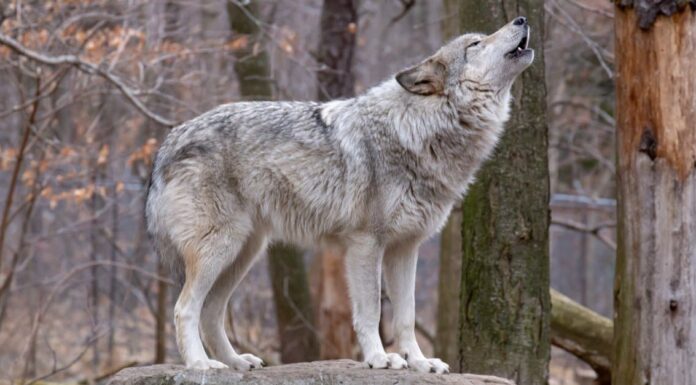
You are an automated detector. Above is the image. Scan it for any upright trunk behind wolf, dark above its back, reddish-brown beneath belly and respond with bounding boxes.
[317,0,358,359]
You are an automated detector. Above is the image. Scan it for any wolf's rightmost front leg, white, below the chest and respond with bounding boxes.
[384,242,449,373]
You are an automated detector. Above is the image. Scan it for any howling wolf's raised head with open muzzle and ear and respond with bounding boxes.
[396,17,534,98]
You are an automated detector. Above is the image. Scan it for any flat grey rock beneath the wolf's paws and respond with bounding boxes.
[104,360,515,385]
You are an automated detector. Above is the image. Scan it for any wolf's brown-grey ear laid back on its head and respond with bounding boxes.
[396,59,447,95]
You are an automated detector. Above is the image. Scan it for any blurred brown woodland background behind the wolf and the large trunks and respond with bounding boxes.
[0,0,616,385]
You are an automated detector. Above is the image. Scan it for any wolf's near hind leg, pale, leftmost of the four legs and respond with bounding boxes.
[174,231,242,369]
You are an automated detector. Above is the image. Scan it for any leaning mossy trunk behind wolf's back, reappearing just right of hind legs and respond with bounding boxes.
[227,1,319,363]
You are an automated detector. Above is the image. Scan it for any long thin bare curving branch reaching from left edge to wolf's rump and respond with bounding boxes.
[0,33,177,127]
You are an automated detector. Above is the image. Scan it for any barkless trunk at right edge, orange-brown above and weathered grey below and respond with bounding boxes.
[612,0,696,385]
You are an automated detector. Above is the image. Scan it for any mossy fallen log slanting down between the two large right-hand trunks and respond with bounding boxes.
[551,289,614,385]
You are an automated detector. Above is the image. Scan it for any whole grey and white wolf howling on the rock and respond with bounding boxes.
[147,18,533,373]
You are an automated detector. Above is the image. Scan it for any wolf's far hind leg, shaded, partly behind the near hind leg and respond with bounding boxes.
[201,231,266,370]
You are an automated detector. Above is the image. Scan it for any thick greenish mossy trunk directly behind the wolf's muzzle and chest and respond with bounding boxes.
[459,0,551,385]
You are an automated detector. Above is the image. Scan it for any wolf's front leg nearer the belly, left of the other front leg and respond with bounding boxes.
[345,235,407,369]
